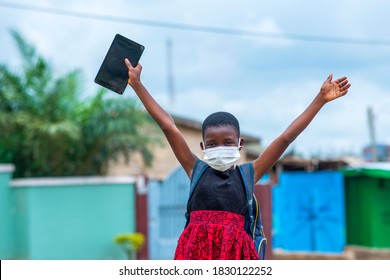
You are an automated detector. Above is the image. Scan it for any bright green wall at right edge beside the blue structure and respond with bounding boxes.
[344,169,390,248]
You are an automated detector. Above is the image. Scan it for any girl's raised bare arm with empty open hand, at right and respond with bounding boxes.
[253,74,351,182]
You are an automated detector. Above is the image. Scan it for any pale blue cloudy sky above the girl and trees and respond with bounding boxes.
[0,0,390,157]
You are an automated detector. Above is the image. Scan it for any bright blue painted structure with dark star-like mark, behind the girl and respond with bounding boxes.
[273,171,346,253]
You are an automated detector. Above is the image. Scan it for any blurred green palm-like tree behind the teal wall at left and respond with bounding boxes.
[0,31,160,177]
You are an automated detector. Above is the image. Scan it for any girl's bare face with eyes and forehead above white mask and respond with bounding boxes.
[200,125,244,150]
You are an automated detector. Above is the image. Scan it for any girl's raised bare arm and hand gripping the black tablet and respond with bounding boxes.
[125,59,198,178]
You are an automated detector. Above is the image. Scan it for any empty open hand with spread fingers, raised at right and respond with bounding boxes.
[320,74,351,102]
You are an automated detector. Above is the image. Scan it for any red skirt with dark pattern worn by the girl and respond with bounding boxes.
[174,210,259,260]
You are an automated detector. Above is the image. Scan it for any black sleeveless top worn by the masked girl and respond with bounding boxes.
[188,167,247,216]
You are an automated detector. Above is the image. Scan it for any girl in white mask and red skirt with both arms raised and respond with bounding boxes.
[125,59,351,260]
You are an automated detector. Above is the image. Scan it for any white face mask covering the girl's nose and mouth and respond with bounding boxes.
[203,146,240,171]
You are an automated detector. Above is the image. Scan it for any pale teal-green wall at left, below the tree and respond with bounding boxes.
[0,164,135,260]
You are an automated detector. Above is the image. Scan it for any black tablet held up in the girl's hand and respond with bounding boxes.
[95,34,145,94]
